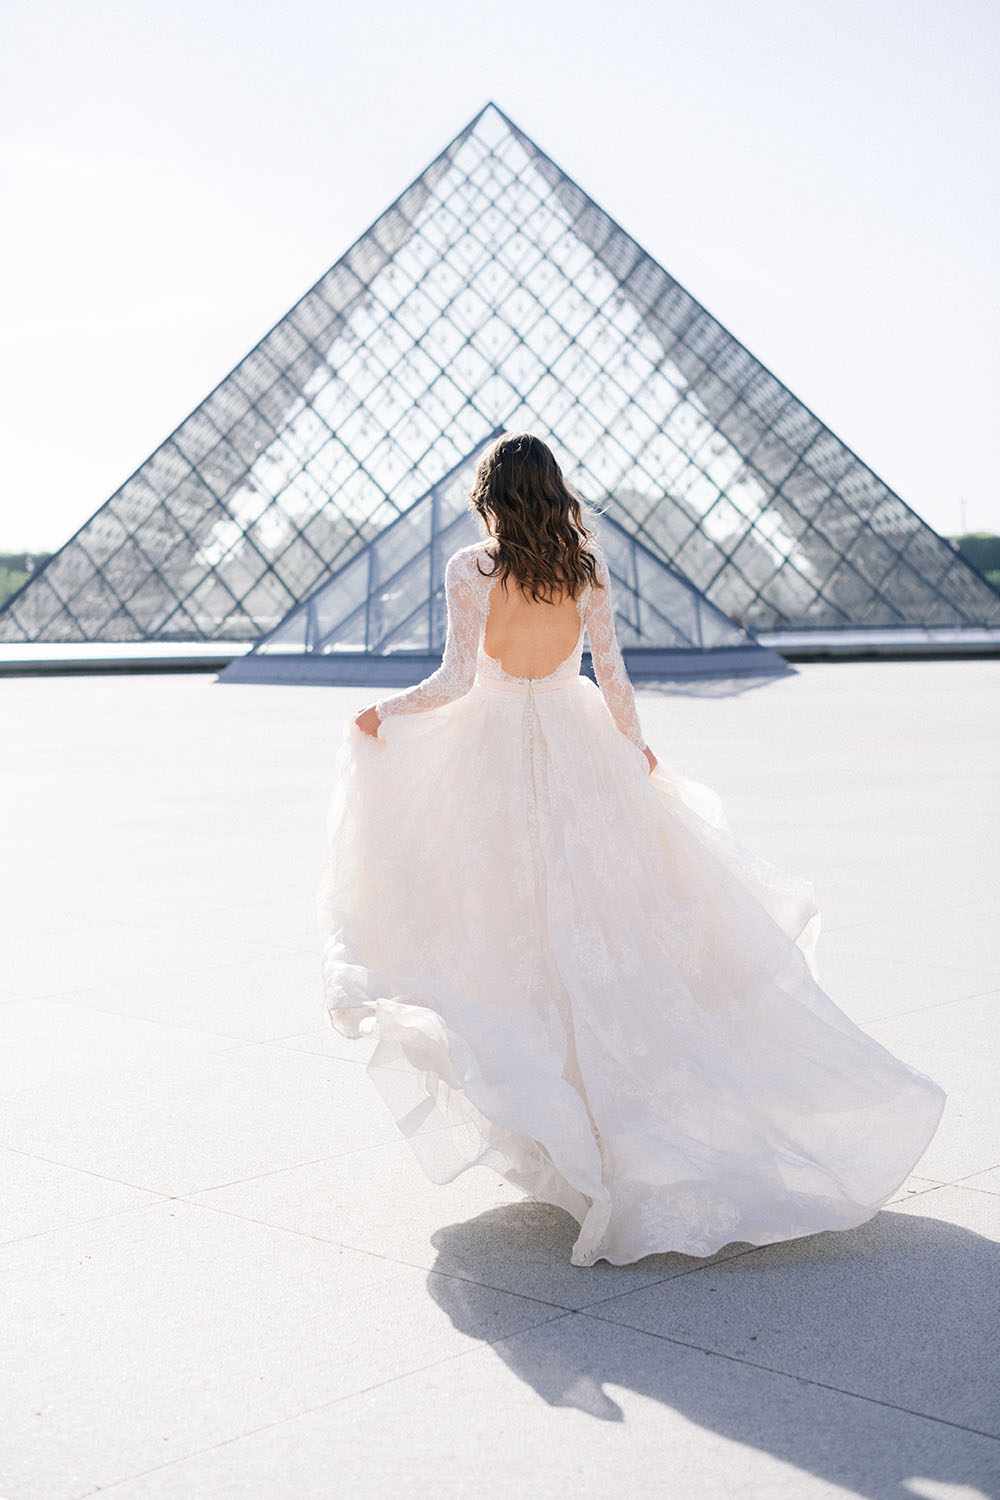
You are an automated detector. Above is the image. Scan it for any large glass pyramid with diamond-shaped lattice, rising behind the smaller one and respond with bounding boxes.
[0,104,1000,641]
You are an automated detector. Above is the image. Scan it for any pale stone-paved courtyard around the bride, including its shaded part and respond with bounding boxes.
[0,660,1000,1500]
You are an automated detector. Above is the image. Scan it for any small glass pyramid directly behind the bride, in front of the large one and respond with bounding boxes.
[222,432,786,686]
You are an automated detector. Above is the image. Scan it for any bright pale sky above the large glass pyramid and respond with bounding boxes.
[0,0,1000,551]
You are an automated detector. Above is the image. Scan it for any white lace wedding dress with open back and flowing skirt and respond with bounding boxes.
[319,543,945,1266]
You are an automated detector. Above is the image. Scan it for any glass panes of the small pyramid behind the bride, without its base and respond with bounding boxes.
[250,449,748,656]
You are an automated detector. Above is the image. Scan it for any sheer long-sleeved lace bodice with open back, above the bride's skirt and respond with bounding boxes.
[375,542,646,750]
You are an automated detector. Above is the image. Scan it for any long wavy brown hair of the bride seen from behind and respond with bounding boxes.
[469,432,603,605]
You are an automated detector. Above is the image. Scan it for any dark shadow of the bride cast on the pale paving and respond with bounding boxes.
[429,1190,1000,1500]
